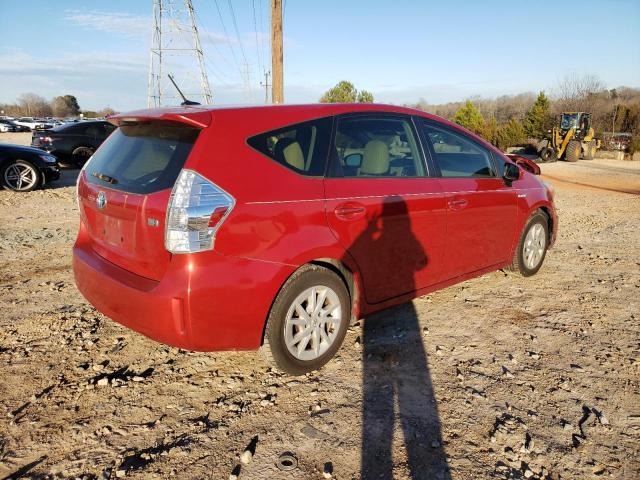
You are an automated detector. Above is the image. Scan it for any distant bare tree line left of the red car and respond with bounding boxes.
[0,93,115,118]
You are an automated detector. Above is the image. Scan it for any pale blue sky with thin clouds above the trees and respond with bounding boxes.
[0,0,640,111]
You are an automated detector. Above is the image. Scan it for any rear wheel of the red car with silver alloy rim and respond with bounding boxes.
[261,265,351,375]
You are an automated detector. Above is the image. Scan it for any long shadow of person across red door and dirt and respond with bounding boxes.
[351,196,450,480]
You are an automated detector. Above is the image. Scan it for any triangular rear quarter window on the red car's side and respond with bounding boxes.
[247,117,332,177]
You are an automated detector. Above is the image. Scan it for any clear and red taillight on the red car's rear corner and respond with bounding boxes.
[164,169,235,253]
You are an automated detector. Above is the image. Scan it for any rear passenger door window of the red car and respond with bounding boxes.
[332,116,425,177]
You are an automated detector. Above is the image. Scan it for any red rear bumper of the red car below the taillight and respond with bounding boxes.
[73,231,292,351]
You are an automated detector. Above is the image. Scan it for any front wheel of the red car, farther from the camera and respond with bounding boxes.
[508,210,549,277]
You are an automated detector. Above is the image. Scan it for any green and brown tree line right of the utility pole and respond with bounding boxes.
[320,75,640,151]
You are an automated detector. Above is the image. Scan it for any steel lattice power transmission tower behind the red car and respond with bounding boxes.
[147,0,213,108]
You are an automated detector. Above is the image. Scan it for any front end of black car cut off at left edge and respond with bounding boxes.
[0,144,60,192]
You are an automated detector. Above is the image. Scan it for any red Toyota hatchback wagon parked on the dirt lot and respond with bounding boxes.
[73,104,558,374]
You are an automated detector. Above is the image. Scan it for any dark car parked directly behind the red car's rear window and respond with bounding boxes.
[31,121,116,165]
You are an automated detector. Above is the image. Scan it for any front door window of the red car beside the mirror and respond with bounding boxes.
[423,122,496,177]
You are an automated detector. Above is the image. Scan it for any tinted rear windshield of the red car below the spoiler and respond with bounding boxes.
[85,122,200,194]
